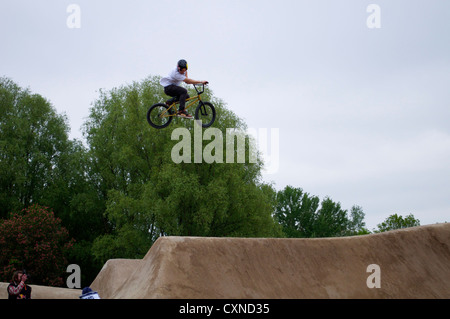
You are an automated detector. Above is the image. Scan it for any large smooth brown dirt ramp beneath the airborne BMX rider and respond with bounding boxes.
[92,224,450,298]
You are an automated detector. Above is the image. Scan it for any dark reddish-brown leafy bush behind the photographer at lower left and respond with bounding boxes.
[0,204,74,286]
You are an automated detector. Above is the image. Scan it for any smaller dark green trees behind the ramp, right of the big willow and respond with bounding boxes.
[275,186,367,238]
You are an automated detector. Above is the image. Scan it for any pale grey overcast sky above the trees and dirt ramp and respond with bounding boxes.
[0,0,450,230]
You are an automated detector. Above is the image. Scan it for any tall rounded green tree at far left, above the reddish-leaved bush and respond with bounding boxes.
[0,78,69,217]
